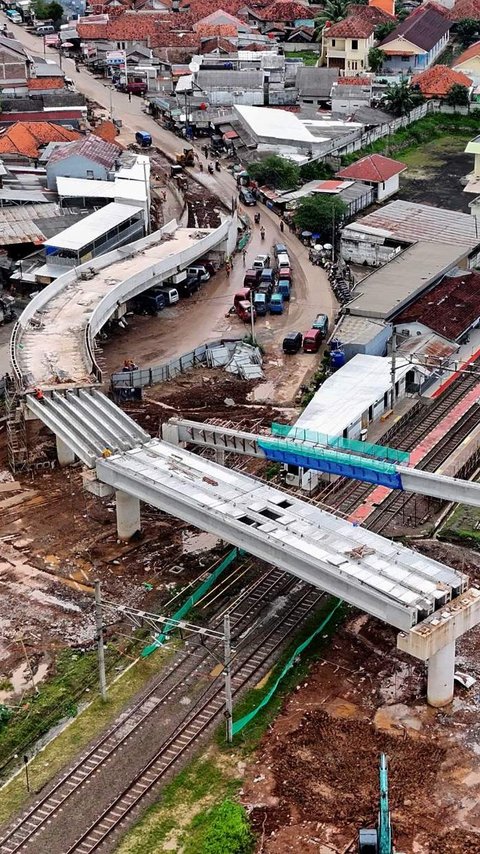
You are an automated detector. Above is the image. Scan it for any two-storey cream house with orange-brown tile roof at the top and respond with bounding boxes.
[323,15,375,74]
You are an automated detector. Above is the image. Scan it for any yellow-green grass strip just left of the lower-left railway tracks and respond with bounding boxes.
[0,648,173,824]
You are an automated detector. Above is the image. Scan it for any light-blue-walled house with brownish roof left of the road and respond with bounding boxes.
[47,134,121,190]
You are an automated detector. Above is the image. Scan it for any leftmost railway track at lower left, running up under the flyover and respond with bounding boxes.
[0,568,306,854]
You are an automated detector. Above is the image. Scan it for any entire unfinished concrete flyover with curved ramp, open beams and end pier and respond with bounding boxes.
[6,219,480,706]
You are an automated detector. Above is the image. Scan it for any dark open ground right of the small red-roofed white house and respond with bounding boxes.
[398,134,472,213]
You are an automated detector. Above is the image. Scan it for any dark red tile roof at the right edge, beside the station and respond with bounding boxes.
[395,271,480,341]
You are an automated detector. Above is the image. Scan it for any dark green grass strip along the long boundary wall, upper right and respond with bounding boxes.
[341,110,480,166]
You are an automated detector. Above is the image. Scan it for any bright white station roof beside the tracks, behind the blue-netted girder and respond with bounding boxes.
[294,353,411,436]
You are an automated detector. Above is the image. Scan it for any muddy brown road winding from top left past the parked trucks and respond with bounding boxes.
[0,15,336,401]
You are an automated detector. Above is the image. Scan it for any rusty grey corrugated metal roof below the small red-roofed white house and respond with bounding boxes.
[343,200,480,249]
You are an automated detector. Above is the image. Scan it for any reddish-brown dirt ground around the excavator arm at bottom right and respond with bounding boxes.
[242,580,480,854]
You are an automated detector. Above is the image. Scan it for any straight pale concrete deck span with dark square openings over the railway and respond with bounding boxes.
[97,440,467,629]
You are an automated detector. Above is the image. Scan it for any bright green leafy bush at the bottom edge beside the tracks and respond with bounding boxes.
[183,800,255,854]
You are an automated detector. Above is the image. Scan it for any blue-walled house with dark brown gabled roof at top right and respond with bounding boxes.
[380,8,452,74]
